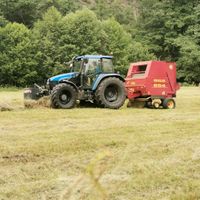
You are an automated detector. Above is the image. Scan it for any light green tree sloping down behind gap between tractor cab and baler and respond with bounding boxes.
[102,19,155,75]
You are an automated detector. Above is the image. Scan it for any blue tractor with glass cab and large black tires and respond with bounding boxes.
[24,55,126,109]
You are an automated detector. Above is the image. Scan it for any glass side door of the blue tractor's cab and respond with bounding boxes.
[83,59,102,89]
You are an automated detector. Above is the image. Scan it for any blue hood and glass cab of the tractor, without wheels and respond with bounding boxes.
[47,55,114,90]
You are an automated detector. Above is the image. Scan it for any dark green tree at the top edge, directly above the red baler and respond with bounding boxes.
[138,0,195,60]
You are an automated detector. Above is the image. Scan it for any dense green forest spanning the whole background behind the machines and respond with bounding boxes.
[0,0,200,87]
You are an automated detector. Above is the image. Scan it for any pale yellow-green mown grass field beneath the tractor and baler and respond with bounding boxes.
[0,87,200,200]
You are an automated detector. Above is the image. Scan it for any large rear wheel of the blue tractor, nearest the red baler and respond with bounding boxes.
[95,77,126,109]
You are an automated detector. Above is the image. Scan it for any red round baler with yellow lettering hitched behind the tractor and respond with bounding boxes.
[125,61,180,109]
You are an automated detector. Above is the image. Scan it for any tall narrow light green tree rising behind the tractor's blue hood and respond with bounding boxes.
[33,7,64,79]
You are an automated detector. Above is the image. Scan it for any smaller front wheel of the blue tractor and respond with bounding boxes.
[51,83,77,109]
